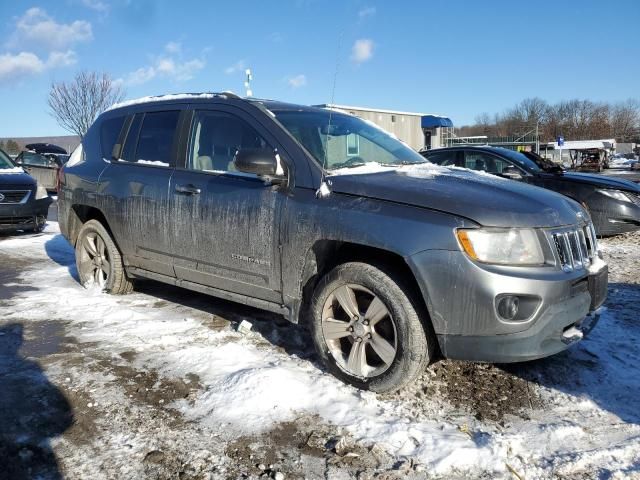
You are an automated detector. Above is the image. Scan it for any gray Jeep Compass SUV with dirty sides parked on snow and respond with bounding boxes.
[59,94,607,392]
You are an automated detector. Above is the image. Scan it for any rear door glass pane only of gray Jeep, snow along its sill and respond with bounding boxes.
[135,110,180,166]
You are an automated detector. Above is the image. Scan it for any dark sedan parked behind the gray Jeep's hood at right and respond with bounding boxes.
[423,146,640,236]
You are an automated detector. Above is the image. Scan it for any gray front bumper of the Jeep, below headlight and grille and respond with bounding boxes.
[410,251,608,363]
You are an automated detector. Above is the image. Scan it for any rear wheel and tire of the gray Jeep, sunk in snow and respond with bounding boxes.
[76,220,133,295]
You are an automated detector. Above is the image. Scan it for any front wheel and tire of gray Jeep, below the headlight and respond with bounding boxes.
[311,262,434,393]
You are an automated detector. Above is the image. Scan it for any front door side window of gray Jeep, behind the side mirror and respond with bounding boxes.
[189,111,270,172]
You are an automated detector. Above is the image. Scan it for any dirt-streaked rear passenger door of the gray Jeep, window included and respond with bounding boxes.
[99,106,181,277]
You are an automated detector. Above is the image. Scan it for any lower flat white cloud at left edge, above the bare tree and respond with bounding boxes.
[0,50,77,84]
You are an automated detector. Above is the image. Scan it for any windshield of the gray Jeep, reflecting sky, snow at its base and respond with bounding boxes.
[274,111,426,170]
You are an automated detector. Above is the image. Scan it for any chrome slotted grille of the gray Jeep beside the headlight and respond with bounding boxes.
[551,223,598,272]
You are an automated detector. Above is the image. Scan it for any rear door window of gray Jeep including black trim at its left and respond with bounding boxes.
[122,110,180,167]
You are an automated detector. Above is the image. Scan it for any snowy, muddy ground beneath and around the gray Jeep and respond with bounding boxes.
[0,222,640,479]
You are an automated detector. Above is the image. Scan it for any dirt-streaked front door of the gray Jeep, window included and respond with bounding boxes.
[170,106,286,302]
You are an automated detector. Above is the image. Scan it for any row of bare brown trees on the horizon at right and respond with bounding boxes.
[456,97,640,143]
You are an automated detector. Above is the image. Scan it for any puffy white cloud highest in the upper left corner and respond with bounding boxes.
[8,7,93,51]
